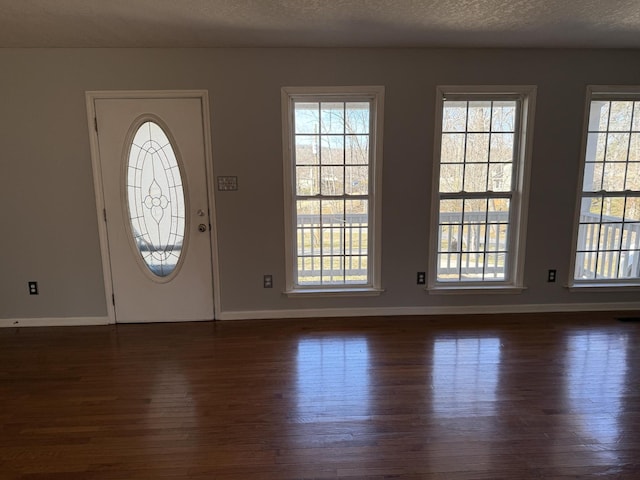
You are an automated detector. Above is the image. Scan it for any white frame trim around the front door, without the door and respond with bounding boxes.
[85,90,220,324]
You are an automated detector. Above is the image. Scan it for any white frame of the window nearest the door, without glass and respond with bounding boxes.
[281,86,384,296]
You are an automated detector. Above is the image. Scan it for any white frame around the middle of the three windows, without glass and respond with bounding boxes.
[427,85,537,294]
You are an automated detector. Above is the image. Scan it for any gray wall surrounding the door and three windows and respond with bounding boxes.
[0,49,640,318]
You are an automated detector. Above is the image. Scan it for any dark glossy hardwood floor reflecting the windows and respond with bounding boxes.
[0,312,640,480]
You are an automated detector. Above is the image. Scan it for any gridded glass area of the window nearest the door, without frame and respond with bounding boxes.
[296,97,371,285]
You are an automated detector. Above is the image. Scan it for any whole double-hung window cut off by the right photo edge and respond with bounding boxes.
[572,87,640,286]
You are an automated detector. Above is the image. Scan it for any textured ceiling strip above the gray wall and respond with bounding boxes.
[0,0,640,48]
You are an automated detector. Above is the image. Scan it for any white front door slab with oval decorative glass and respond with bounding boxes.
[89,94,214,322]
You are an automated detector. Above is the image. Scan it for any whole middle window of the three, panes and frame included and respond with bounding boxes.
[429,86,536,291]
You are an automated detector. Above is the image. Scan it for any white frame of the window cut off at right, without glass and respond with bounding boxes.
[568,85,640,291]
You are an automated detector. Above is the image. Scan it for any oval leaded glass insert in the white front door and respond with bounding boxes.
[126,120,185,281]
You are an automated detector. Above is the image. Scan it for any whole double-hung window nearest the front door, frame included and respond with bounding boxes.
[282,87,384,294]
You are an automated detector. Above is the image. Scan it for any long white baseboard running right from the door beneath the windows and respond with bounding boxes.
[217,302,640,320]
